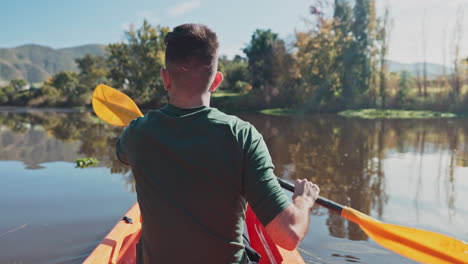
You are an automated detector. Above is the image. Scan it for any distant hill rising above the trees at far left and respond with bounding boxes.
[0,44,105,82]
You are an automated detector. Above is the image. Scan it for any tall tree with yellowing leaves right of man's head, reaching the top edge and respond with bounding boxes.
[295,0,353,111]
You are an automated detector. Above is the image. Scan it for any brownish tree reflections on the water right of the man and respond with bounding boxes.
[239,115,468,240]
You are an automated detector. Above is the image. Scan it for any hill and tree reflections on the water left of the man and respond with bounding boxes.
[0,111,129,174]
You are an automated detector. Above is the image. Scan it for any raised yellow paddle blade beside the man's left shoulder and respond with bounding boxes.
[92,84,143,126]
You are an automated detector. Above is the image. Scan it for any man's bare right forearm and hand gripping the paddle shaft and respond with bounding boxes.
[265,179,320,250]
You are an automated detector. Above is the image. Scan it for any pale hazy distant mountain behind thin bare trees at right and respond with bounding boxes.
[386,60,453,78]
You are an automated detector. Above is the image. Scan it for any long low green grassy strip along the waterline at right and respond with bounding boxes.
[338,109,458,119]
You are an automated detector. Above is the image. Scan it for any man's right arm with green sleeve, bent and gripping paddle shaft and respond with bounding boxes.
[241,126,320,250]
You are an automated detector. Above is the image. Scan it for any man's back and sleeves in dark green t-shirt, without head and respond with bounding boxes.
[117,105,289,263]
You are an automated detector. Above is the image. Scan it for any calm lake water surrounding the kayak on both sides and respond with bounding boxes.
[0,109,468,263]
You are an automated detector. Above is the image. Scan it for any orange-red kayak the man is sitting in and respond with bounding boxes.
[84,203,305,264]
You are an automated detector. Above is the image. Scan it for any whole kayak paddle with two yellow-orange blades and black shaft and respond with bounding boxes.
[92,84,468,264]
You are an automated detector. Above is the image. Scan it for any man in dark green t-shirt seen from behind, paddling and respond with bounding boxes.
[117,24,319,263]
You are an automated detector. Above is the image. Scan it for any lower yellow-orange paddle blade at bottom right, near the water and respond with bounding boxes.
[341,207,468,264]
